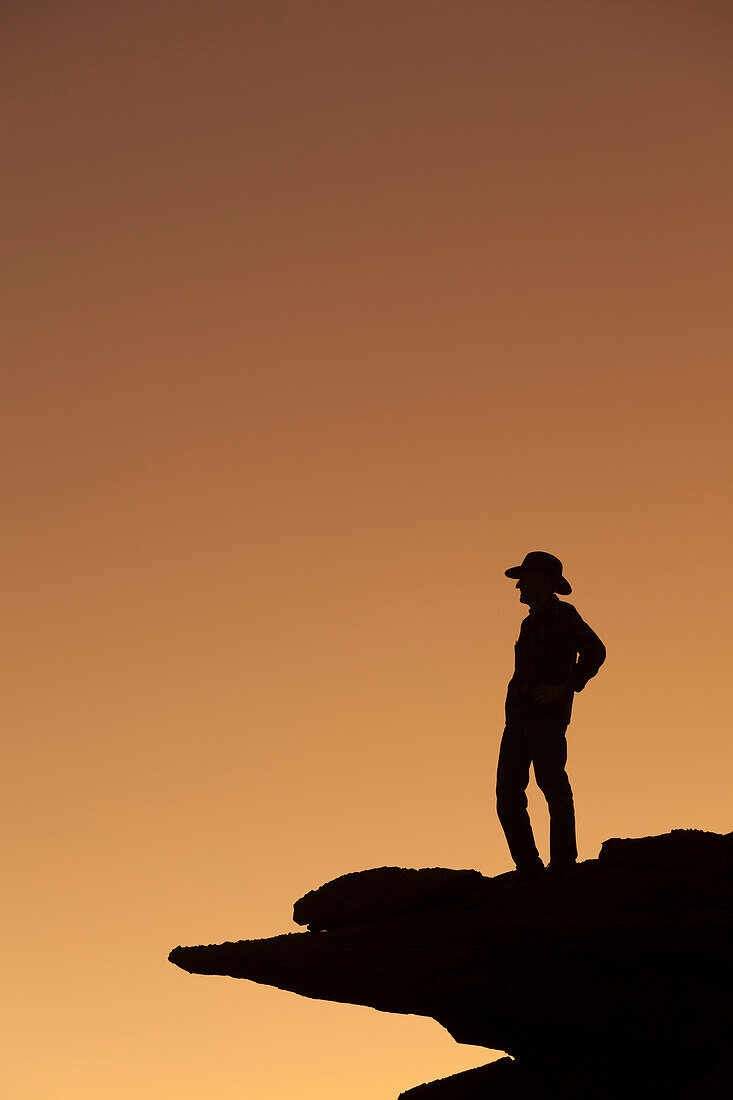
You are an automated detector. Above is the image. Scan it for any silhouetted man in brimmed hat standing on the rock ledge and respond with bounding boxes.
[496,550,605,878]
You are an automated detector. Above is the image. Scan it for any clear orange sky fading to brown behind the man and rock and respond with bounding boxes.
[5,0,733,1100]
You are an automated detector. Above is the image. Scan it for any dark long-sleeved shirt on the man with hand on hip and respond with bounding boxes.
[506,595,605,722]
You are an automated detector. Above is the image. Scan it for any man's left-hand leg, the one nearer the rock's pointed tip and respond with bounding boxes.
[496,725,543,871]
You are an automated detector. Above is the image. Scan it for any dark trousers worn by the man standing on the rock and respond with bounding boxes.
[496,715,578,870]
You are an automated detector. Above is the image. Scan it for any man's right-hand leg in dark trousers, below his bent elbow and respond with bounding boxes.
[528,722,578,867]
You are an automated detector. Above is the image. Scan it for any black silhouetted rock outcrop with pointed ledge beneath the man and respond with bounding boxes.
[169,829,733,1100]
